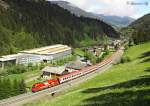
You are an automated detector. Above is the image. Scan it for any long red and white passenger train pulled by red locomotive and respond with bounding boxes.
[32,52,117,92]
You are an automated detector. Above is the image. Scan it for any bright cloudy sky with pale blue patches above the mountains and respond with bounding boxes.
[48,0,150,18]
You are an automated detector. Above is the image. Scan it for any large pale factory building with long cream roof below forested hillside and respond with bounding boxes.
[0,44,72,67]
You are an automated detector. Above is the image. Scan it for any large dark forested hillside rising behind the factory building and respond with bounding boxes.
[0,0,119,55]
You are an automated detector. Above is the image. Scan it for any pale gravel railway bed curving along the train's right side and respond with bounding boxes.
[0,49,123,106]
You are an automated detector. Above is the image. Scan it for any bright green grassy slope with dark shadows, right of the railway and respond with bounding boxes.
[25,42,150,106]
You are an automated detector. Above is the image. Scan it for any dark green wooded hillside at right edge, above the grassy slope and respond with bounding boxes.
[122,14,150,44]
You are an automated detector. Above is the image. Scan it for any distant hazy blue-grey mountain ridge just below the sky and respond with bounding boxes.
[51,1,134,28]
